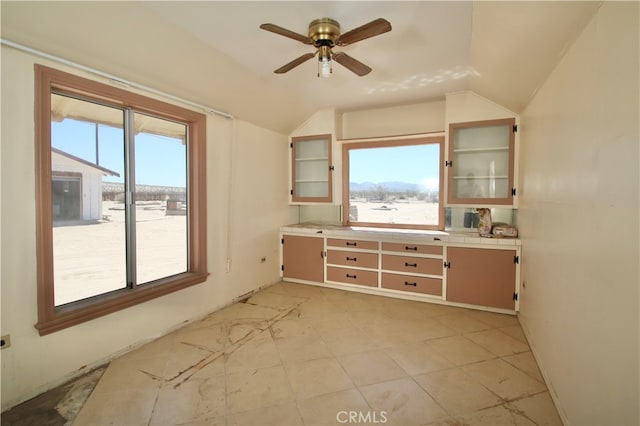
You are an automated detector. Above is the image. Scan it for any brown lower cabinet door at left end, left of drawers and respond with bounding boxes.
[282,235,324,283]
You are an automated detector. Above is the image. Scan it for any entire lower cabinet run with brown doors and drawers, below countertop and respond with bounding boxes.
[282,233,520,312]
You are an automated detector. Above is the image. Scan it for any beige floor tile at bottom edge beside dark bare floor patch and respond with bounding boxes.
[73,388,158,426]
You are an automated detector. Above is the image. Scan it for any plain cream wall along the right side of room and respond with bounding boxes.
[518,2,640,425]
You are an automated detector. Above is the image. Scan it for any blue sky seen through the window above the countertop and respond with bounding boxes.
[349,144,440,189]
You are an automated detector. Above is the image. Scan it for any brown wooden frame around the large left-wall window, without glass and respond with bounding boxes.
[34,64,208,335]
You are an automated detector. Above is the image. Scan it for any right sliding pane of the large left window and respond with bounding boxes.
[134,114,188,284]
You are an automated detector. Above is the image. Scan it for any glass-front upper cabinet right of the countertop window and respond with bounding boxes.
[446,118,516,205]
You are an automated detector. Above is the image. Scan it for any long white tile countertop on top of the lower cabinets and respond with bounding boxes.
[280,223,521,246]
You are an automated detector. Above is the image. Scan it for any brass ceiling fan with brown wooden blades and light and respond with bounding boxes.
[260,18,391,77]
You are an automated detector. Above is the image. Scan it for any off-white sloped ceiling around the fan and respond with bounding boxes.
[1,1,600,133]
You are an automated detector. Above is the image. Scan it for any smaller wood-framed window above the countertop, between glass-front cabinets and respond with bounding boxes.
[342,136,444,230]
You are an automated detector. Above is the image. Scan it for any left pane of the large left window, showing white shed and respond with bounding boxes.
[51,94,126,306]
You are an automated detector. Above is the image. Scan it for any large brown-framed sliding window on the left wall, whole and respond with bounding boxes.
[36,66,207,334]
